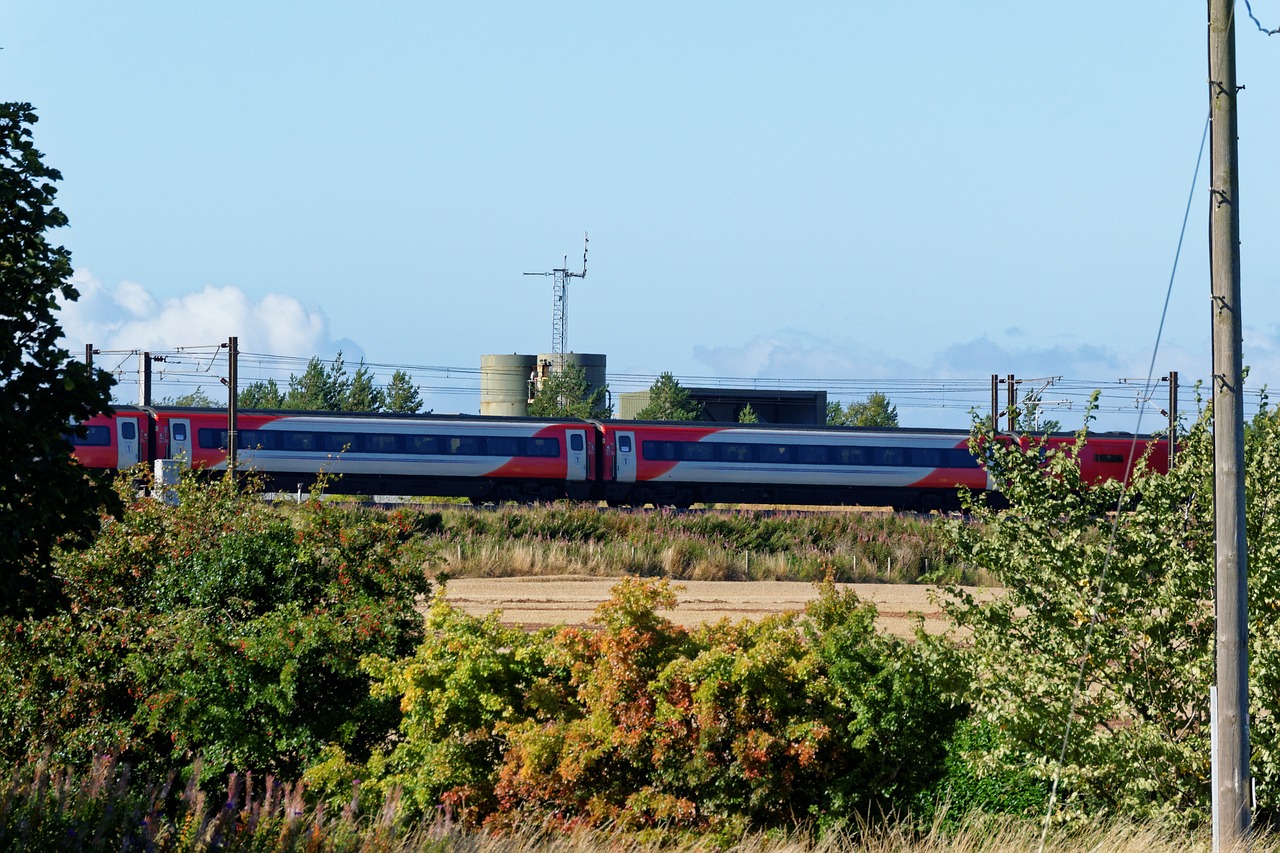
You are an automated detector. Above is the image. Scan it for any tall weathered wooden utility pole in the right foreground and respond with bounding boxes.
[1208,0,1252,849]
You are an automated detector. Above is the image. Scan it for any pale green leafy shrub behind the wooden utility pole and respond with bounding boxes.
[951,410,1280,824]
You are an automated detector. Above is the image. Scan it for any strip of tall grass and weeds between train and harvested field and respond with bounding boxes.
[399,505,989,585]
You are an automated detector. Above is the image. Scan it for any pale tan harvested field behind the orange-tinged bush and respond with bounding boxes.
[445,575,997,637]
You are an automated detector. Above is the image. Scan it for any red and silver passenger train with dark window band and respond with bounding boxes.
[73,407,1167,511]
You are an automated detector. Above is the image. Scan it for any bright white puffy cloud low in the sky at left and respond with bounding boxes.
[59,269,343,357]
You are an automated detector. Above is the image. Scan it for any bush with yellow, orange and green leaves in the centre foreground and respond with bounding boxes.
[322,580,963,833]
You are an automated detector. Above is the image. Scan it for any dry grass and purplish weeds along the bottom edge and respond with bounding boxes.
[0,756,1259,853]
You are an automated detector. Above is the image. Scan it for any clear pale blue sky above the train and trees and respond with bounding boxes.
[10,0,1280,429]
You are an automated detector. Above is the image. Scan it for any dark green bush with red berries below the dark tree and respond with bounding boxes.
[0,478,429,777]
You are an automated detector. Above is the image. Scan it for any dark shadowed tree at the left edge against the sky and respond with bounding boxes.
[0,102,119,615]
